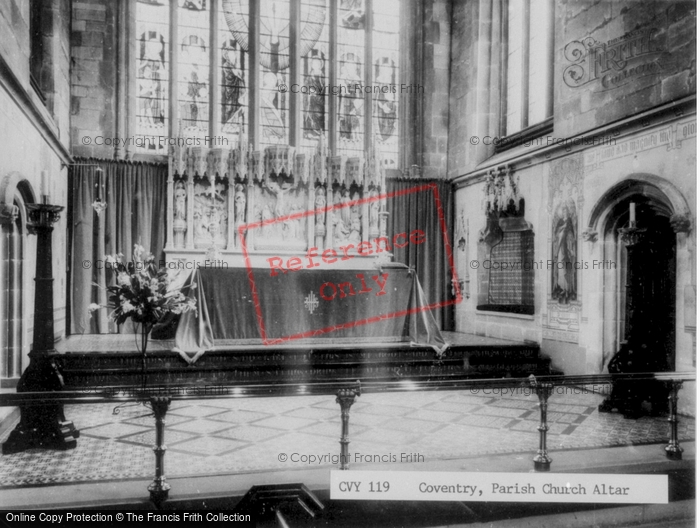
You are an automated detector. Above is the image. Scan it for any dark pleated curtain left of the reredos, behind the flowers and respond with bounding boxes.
[69,158,168,334]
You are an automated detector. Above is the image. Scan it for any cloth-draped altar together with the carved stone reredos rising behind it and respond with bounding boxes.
[165,137,446,364]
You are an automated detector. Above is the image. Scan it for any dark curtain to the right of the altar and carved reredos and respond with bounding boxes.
[387,178,455,331]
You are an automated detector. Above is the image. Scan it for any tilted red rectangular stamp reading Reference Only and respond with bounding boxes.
[238,184,462,345]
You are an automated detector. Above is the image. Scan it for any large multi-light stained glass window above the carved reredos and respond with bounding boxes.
[135,0,405,168]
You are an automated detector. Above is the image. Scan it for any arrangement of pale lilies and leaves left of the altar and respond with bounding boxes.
[88,244,197,330]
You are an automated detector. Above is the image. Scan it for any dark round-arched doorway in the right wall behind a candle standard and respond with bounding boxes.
[587,178,688,372]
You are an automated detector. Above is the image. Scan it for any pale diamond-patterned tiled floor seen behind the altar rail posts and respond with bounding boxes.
[0,390,695,487]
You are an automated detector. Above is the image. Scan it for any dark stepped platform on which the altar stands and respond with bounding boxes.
[56,332,554,388]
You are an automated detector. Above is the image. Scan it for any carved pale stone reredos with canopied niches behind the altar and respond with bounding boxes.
[167,140,389,262]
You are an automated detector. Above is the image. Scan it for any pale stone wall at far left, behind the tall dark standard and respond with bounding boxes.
[0,0,70,368]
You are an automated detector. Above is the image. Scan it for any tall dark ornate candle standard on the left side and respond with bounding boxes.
[2,203,79,454]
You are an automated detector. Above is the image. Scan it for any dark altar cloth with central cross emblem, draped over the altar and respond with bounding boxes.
[175,265,447,362]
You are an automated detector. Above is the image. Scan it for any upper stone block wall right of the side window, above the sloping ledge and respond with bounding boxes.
[554,0,696,138]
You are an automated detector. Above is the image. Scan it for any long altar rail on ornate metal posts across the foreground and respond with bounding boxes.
[0,372,696,506]
